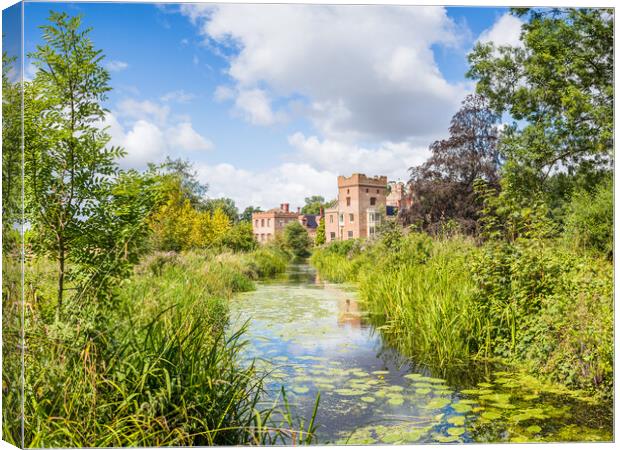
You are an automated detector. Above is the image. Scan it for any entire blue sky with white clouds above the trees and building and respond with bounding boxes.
[8,2,521,210]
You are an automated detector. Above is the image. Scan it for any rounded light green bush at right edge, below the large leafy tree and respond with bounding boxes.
[565,178,614,259]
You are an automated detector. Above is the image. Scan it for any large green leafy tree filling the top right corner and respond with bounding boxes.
[467,8,614,198]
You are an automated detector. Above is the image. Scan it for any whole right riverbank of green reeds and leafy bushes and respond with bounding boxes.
[311,233,613,400]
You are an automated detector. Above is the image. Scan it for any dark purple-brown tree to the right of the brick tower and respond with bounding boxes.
[402,95,500,233]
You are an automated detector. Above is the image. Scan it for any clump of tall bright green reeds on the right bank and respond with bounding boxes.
[359,240,484,367]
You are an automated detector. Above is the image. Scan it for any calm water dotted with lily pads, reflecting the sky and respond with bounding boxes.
[231,265,612,444]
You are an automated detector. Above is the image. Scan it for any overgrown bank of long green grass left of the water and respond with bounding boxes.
[4,249,320,447]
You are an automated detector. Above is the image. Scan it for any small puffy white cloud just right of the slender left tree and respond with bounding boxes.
[103,99,213,169]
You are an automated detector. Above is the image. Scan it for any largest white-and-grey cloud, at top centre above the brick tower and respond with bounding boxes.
[181,4,470,141]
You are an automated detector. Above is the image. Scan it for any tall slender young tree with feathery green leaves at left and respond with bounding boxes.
[24,12,123,311]
